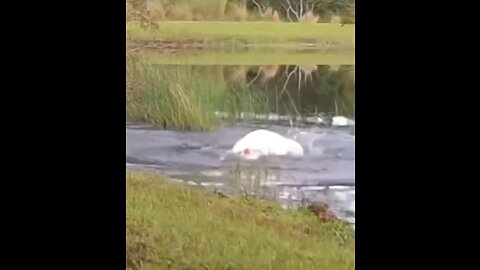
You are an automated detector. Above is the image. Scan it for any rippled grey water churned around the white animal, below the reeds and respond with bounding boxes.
[126,121,355,226]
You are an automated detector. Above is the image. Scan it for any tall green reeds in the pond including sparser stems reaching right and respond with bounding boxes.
[126,58,268,131]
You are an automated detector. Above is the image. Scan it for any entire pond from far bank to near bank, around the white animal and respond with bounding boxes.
[126,51,355,226]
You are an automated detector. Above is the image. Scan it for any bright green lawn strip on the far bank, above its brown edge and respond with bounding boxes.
[127,21,355,42]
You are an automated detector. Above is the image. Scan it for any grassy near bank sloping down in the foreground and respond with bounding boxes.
[126,173,355,270]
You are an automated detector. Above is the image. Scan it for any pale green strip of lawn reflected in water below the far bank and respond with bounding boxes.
[137,50,355,65]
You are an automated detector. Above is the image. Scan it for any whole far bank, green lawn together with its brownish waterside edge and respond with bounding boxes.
[127,21,355,50]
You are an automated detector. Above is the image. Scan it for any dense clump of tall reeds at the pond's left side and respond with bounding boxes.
[126,57,218,130]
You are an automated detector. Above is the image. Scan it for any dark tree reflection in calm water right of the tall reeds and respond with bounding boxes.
[246,65,355,117]
